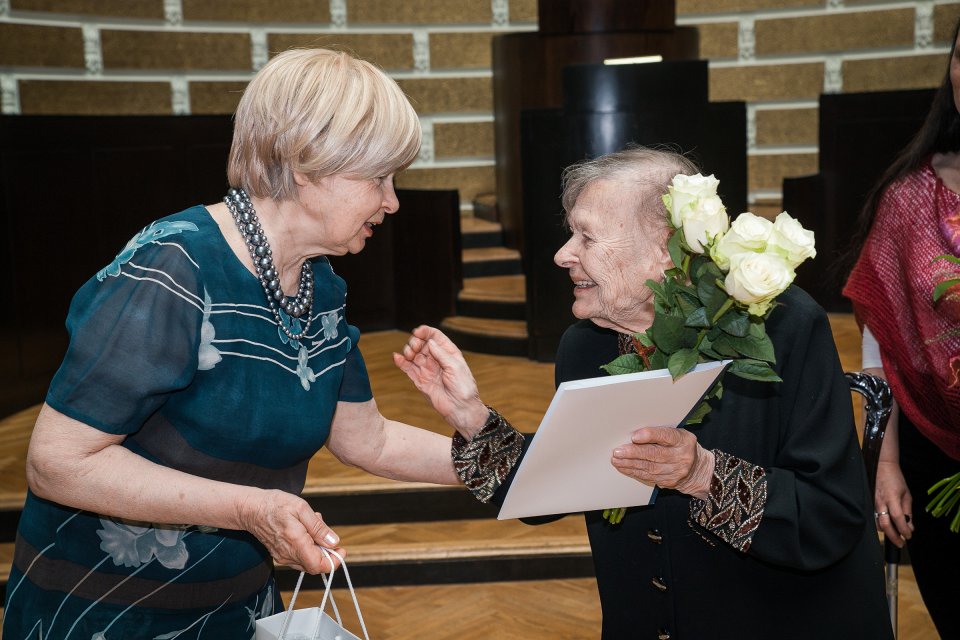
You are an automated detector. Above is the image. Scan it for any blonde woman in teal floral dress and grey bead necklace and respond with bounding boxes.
[3,50,459,640]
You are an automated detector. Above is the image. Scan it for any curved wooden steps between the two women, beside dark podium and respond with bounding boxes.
[440,217,527,357]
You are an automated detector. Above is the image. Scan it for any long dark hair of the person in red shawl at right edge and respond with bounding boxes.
[840,20,960,278]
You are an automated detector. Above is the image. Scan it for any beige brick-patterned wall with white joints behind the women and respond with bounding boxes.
[0,0,960,213]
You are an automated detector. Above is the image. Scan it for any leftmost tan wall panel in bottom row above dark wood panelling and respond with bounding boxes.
[20,80,172,115]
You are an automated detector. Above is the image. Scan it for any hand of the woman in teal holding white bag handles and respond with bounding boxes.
[240,490,346,575]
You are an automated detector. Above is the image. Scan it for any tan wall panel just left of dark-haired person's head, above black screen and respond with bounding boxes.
[842,54,947,93]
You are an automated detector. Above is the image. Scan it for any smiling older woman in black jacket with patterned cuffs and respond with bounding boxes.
[398,149,891,640]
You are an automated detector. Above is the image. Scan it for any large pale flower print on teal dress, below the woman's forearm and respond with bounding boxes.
[97,517,190,569]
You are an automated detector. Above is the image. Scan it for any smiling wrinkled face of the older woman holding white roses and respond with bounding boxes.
[554,180,670,331]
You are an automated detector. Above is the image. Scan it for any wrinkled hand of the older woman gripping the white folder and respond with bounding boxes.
[612,427,715,499]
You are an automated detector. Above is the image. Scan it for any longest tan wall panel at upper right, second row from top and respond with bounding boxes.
[755,9,914,56]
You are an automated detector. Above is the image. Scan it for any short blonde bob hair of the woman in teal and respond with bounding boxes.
[227,49,421,201]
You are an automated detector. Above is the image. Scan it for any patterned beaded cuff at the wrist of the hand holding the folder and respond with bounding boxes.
[690,449,767,552]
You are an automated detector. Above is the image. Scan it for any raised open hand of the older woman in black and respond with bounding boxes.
[393,326,488,440]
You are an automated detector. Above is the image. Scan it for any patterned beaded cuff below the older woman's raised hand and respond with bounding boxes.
[450,407,523,502]
